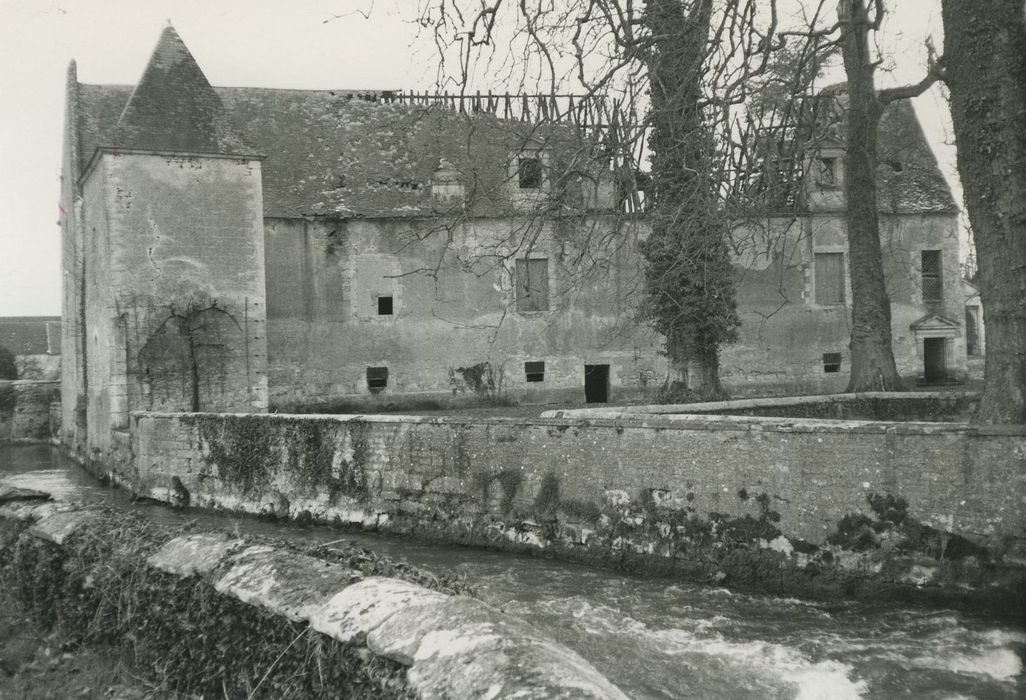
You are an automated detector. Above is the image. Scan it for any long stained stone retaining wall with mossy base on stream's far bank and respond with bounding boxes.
[124,414,1026,609]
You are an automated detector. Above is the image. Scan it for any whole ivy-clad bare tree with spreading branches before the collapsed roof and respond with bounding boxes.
[404,0,837,395]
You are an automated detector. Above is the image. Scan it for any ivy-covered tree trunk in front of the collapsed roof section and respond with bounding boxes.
[642,0,740,400]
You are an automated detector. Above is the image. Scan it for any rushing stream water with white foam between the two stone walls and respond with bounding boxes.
[0,445,1026,700]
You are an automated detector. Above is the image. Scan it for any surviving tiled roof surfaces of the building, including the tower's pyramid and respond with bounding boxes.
[74,41,957,218]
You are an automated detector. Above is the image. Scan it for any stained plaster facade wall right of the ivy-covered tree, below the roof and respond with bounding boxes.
[720,212,966,396]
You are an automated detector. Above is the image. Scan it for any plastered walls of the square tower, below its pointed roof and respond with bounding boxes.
[82,153,267,456]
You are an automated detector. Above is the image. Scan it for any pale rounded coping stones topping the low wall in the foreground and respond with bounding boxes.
[0,503,627,700]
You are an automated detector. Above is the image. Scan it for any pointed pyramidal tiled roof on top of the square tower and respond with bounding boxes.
[106,25,252,154]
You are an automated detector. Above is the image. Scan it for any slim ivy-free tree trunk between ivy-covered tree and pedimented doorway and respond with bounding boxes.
[838,0,904,392]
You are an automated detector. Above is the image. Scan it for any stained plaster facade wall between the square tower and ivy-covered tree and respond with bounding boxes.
[266,218,665,405]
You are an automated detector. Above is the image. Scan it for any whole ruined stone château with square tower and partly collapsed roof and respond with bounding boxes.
[62,27,965,457]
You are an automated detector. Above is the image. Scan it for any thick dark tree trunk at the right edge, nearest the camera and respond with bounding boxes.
[942,0,1026,424]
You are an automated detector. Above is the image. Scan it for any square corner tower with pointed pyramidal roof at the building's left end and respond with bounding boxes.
[62,30,267,460]
